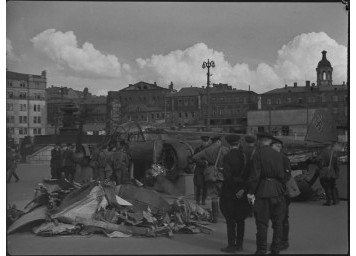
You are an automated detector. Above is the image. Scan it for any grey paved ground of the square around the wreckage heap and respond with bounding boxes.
[7,165,348,255]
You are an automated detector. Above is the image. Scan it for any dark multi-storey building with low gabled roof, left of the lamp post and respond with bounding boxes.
[107,81,174,132]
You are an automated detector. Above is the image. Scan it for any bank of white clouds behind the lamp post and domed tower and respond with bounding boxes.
[136,32,347,92]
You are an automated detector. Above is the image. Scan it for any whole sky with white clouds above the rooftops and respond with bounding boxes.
[6,1,348,95]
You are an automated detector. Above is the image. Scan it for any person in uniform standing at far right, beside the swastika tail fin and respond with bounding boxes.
[317,143,339,206]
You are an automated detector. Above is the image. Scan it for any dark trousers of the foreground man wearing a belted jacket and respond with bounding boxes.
[254,196,286,253]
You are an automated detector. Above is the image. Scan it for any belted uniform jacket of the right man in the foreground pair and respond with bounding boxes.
[249,146,287,198]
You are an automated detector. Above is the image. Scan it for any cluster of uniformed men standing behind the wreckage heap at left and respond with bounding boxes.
[50,140,131,185]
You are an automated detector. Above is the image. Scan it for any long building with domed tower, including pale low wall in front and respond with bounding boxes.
[248,50,349,141]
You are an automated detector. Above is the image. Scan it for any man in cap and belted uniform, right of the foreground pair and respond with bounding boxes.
[247,133,286,254]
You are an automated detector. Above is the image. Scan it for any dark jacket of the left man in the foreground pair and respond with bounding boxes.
[221,148,249,199]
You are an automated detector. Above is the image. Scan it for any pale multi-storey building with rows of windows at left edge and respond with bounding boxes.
[6,71,47,143]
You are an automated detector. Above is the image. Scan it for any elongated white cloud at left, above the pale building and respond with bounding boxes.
[31,29,130,78]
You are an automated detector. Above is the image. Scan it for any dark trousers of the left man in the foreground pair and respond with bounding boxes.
[220,197,249,246]
